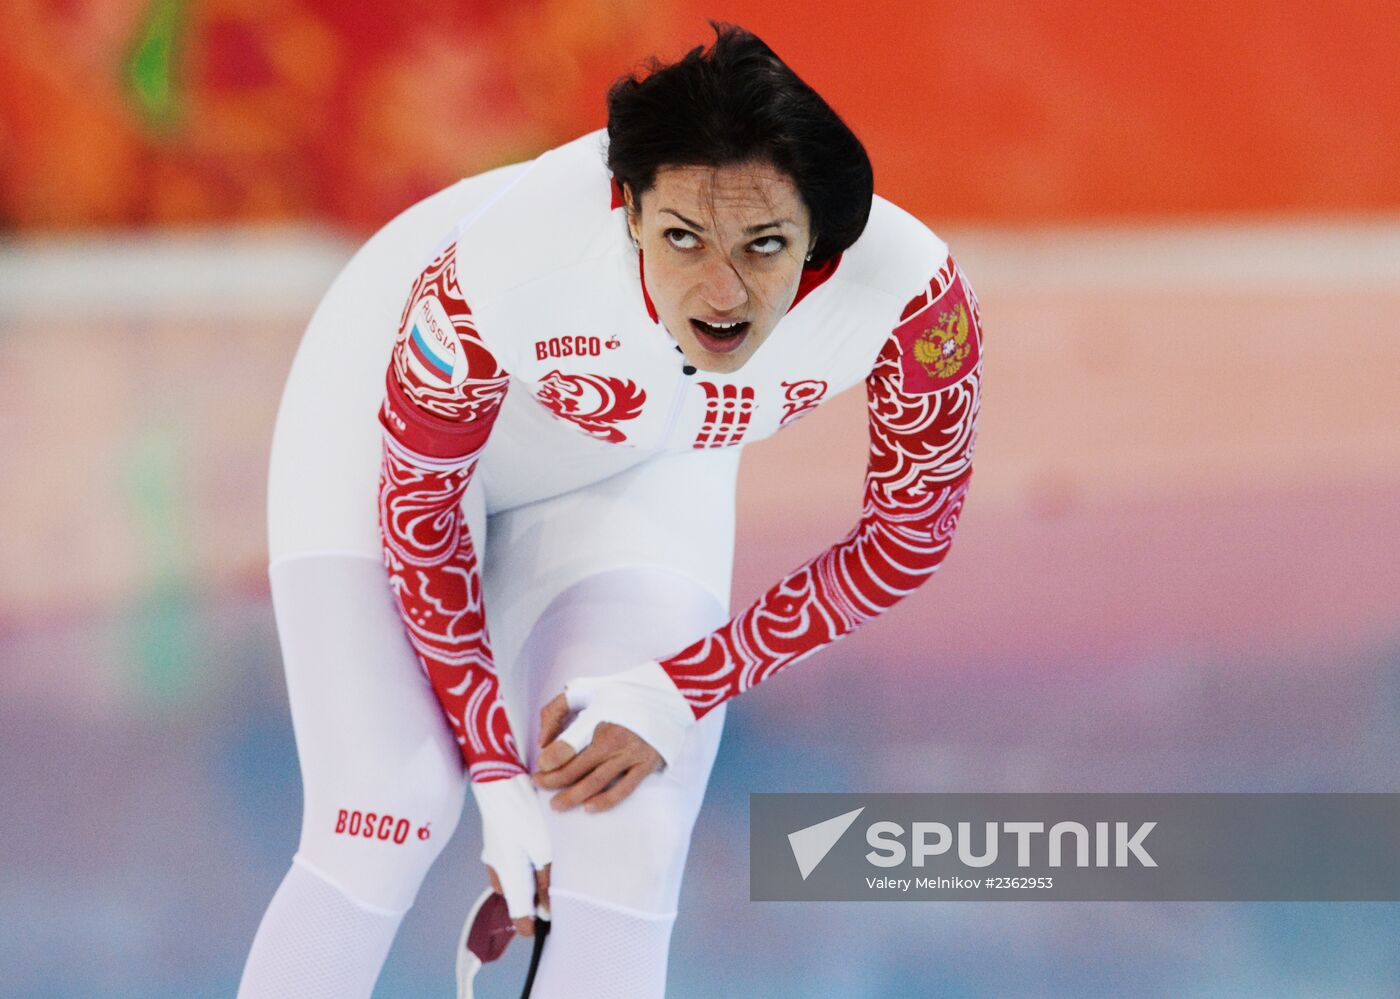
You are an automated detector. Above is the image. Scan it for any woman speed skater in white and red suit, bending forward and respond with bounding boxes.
[239,25,981,999]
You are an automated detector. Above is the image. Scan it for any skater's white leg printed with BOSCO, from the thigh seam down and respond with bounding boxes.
[239,555,465,999]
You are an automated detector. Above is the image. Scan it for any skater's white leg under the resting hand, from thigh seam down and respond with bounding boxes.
[519,568,725,999]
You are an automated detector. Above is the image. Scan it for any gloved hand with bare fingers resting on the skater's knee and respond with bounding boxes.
[535,662,694,812]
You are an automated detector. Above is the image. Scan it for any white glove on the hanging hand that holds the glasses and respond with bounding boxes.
[472,774,552,919]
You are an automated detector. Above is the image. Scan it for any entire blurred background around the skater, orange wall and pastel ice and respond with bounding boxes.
[0,0,1400,996]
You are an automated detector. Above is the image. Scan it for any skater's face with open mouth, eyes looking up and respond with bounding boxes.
[623,161,815,372]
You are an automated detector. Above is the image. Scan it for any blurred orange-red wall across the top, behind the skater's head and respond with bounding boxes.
[0,0,1400,231]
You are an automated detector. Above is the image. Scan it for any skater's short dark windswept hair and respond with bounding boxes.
[608,21,875,263]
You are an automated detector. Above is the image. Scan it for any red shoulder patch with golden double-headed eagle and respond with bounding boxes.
[893,257,981,395]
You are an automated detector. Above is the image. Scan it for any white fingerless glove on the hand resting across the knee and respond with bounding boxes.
[559,660,696,767]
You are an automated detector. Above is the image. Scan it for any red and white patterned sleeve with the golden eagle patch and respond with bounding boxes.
[661,257,981,718]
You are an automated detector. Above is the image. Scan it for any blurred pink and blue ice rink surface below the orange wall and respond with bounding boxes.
[0,220,1400,999]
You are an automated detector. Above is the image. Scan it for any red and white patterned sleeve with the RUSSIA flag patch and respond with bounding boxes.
[379,243,526,781]
